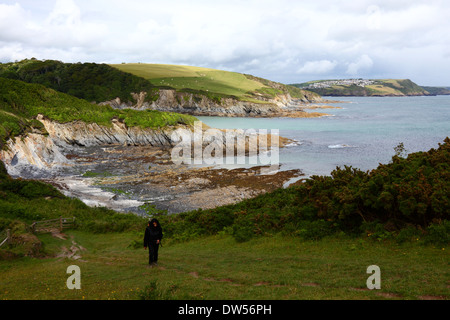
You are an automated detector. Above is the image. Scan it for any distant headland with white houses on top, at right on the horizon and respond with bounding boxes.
[293,79,430,96]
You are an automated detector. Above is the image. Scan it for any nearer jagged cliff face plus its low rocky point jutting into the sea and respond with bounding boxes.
[0,115,284,177]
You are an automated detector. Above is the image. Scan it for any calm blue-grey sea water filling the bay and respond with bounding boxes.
[198,96,450,176]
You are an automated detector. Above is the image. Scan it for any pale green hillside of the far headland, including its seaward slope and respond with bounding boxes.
[111,63,320,103]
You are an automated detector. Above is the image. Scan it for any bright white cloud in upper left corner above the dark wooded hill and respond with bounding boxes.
[0,0,107,60]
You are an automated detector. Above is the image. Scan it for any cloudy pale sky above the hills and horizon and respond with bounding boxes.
[0,0,450,86]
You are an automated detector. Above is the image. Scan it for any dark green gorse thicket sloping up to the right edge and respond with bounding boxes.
[163,138,450,243]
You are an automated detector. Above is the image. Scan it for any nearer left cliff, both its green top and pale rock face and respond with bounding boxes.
[0,77,288,176]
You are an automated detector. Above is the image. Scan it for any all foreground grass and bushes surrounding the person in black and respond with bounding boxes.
[0,138,450,300]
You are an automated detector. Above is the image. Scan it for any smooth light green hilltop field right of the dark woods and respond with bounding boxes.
[111,63,269,99]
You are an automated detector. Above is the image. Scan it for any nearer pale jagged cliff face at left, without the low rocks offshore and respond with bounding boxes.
[0,115,189,176]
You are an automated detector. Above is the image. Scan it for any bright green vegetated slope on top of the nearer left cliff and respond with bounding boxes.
[0,77,196,147]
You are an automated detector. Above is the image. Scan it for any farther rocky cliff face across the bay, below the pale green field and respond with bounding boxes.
[101,89,322,117]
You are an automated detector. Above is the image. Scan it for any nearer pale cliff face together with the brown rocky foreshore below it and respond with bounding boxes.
[0,116,301,214]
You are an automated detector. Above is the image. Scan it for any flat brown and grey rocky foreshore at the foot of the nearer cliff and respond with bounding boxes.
[46,140,303,215]
